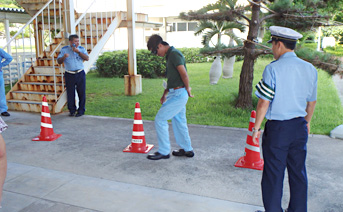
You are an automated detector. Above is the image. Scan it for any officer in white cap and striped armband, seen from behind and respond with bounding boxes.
[253,26,317,212]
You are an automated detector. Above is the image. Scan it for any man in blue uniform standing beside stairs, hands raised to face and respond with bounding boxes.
[57,35,89,117]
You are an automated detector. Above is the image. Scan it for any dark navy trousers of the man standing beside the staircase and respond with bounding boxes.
[65,71,86,114]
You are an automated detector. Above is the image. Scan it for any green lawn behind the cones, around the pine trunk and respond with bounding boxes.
[86,59,343,134]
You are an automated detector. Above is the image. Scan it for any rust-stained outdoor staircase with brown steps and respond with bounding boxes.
[6,0,116,114]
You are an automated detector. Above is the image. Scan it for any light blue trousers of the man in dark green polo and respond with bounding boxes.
[155,88,193,155]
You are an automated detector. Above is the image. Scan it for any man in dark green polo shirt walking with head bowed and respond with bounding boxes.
[147,35,194,160]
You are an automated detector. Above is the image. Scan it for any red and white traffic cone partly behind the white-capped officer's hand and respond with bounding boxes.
[235,110,264,170]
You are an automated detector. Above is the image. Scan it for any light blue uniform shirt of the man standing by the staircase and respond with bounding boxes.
[57,46,88,71]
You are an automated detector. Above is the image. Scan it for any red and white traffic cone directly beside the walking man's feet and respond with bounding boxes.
[123,102,154,153]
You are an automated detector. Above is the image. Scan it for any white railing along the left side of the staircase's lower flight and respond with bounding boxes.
[3,0,63,88]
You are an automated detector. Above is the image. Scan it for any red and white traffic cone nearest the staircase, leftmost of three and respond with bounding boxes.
[32,96,62,141]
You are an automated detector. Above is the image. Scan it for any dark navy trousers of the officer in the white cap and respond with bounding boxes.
[261,117,308,212]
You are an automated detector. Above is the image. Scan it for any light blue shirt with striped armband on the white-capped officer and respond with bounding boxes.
[255,52,317,120]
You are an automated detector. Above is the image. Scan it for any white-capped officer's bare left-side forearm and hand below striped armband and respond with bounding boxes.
[252,98,270,145]
